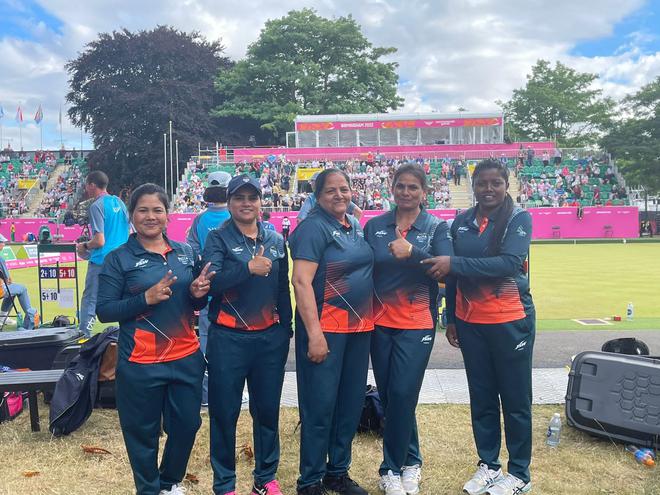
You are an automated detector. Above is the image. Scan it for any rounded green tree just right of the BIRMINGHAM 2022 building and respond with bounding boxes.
[498,60,614,147]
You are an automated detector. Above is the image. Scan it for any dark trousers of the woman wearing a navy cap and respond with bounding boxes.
[206,323,291,494]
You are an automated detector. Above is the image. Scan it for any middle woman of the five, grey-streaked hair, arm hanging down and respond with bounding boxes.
[289,169,374,495]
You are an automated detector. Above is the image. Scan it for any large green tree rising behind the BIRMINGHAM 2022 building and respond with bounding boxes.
[214,9,403,141]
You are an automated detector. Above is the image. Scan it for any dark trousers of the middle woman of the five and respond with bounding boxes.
[296,324,372,488]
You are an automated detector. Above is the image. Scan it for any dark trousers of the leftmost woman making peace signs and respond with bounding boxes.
[116,351,206,495]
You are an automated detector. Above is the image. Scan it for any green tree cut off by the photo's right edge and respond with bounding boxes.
[600,76,660,193]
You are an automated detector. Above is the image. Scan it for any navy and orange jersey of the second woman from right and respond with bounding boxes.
[364,209,453,330]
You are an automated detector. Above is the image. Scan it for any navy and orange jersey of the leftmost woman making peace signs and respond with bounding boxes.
[96,234,206,364]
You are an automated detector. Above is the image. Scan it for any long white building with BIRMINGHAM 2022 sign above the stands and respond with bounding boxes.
[287,113,504,148]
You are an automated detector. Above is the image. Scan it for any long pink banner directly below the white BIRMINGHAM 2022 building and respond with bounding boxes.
[234,141,555,163]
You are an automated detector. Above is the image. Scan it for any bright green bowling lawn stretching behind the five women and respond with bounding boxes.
[6,243,660,331]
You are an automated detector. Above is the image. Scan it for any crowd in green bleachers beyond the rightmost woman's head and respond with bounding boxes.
[516,152,627,207]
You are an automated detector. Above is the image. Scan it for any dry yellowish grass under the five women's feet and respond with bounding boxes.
[0,405,660,495]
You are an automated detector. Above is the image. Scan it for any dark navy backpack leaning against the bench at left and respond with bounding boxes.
[48,327,119,437]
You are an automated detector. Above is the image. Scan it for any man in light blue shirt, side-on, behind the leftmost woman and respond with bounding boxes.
[76,170,129,337]
